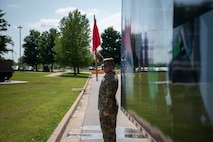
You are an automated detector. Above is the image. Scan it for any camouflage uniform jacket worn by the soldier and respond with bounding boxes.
[98,72,118,113]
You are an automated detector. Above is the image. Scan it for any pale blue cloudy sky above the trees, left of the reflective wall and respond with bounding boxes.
[0,0,121,62]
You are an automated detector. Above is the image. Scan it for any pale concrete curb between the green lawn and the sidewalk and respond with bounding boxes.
[47,75,90,142]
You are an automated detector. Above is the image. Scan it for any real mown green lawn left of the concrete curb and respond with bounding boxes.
[0,72,88,142]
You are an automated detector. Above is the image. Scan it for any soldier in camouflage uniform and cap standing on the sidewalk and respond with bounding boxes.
[96,52,118,142]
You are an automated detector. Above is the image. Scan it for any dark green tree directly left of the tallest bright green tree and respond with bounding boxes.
[39,28,59,71]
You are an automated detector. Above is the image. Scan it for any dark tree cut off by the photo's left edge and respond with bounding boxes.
[0,10,12,58]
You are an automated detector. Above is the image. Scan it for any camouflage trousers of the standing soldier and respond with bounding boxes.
[99,111,118,142]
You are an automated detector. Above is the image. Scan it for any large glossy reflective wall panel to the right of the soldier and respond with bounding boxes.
[121,0,213,142]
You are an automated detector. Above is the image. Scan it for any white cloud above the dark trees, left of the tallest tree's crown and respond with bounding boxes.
[28,19,60,32]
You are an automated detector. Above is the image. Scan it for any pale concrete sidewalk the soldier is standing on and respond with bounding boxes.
[48,74,148,142]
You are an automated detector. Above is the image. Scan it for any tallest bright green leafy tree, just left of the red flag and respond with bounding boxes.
[54,10,92,75]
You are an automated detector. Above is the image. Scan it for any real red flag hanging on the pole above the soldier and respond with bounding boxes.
[92,16,101,52]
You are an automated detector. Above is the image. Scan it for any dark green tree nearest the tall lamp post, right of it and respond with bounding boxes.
[23,30,40,71]
